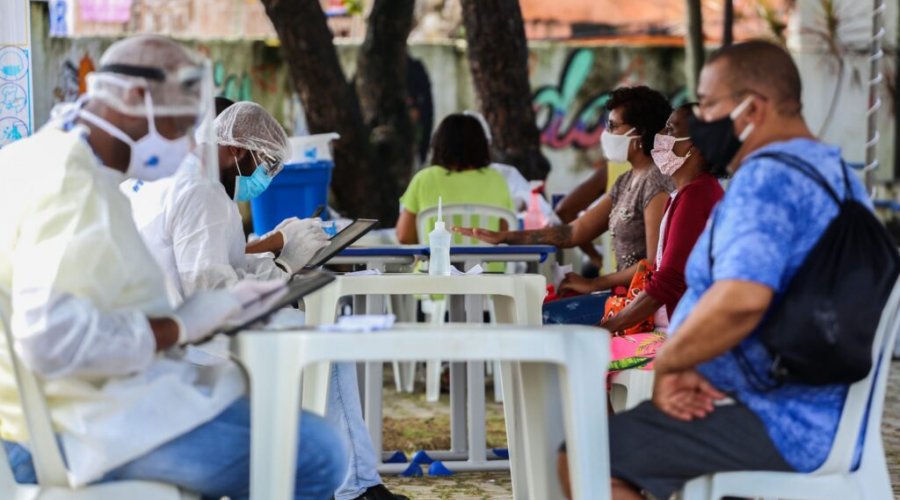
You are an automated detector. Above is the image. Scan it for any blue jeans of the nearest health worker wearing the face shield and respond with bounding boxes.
[4,398,347,500]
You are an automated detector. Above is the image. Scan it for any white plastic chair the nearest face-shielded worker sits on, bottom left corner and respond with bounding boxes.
[0,307,199,500]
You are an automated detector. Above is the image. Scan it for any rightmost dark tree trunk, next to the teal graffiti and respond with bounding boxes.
[462,0,550,179]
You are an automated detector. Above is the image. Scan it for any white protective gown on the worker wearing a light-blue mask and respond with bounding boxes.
[122,156,289,304]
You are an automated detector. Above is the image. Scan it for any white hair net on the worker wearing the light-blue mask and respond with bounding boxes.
[215,101,291,164]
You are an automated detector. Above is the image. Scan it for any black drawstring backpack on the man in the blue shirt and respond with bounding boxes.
[709,153,900,390]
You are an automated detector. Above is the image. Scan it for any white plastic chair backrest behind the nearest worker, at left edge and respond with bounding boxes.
[0,298,69,488]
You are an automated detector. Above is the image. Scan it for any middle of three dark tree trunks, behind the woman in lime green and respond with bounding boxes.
[356,0,416,221]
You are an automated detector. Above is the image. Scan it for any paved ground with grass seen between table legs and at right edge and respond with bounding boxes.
[384,361,900,500]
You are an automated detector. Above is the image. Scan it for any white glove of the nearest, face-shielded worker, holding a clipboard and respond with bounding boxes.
[173,280,286,344]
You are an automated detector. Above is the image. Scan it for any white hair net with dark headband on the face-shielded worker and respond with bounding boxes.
[87,35,205,116]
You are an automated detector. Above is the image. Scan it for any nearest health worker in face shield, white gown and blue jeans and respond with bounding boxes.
[0,36,347,499]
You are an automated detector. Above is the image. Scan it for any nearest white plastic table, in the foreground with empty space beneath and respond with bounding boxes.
[238,325,610,500]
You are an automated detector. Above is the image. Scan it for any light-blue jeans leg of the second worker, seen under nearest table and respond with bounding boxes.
[325,363,381,500]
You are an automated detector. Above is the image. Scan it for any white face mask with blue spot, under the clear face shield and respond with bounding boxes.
[78,86,194,181]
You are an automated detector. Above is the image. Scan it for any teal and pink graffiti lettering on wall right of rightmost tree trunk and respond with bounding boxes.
[532,49,687,149]
